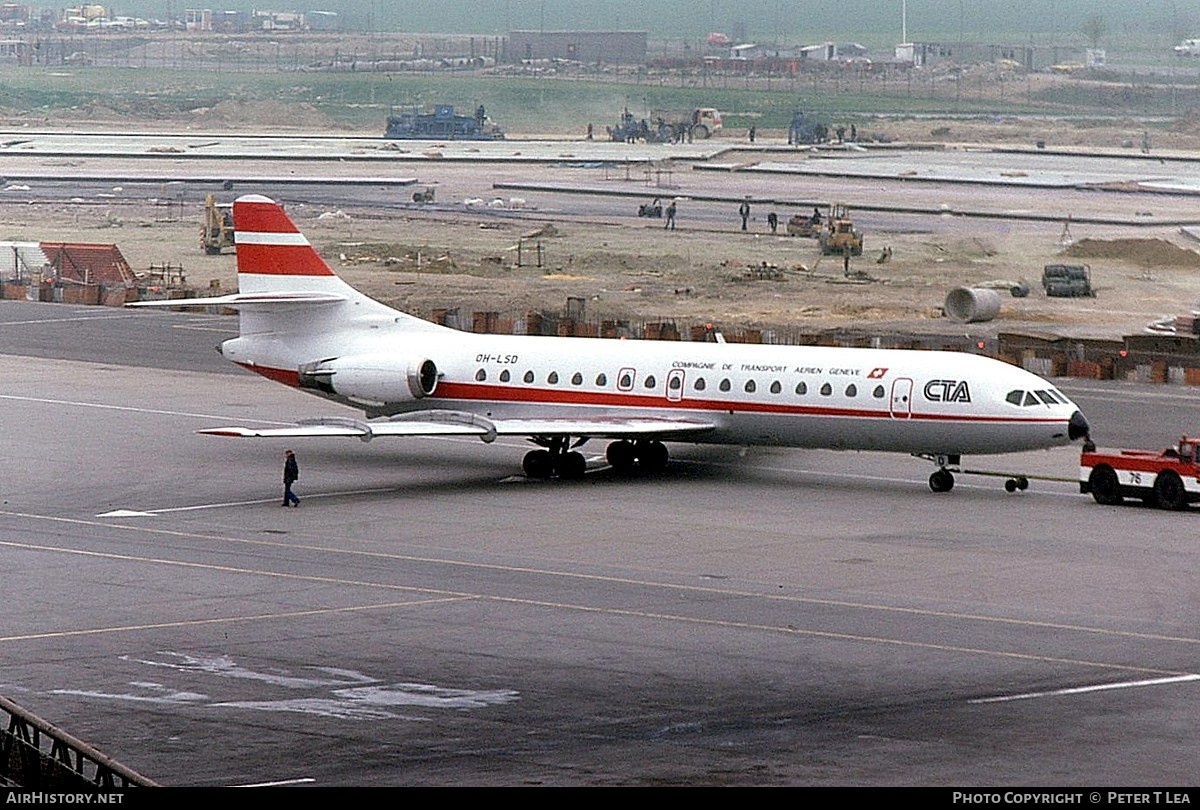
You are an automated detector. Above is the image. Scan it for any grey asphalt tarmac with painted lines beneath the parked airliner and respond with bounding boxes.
[0,301,1200,787]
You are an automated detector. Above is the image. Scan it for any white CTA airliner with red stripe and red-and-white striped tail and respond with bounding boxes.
[133,196,1088,492]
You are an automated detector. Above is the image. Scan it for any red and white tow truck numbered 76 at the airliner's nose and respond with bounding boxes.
[1079,436,1200,510]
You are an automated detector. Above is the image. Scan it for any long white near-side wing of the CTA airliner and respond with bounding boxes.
[199,410,716,442]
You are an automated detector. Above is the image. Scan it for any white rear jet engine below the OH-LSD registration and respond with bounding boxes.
[299,354,438,404]
